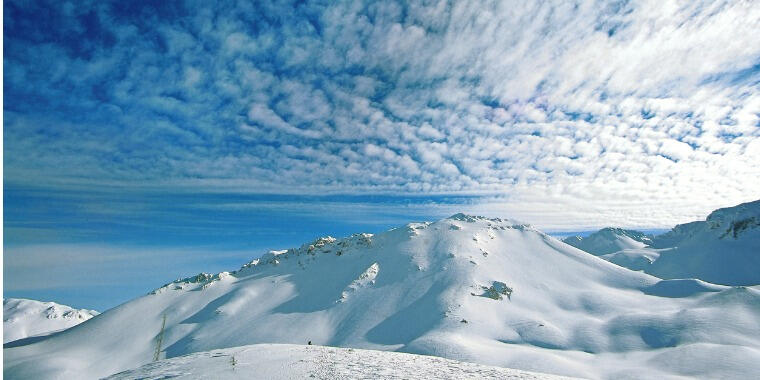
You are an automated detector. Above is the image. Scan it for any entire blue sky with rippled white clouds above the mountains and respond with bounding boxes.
[3,0,760,309]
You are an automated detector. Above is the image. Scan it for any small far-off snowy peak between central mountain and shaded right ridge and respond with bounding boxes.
[563,227,652,256]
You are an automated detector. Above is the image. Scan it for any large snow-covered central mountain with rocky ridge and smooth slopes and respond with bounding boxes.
[4,214,760,379]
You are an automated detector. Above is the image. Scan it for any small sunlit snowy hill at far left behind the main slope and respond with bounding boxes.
[3,298,98,343]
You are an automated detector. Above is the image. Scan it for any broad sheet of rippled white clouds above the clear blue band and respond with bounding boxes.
[5,0,760,229]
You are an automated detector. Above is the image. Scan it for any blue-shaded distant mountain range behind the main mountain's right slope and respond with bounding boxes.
[564,201,760,285]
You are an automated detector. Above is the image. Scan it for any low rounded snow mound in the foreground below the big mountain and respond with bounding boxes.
[108,344,580,380]
